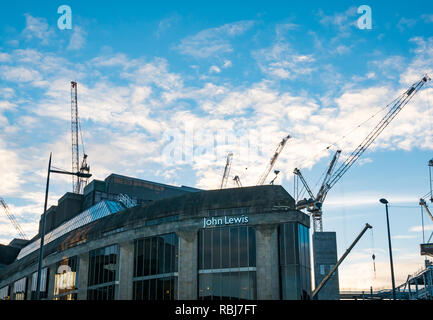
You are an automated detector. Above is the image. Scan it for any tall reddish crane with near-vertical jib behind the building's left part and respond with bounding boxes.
[71,81,90,194]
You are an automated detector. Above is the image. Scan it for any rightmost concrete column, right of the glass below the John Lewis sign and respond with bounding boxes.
[256,224,280,300]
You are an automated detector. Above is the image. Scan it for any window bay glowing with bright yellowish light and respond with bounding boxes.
[54,256,78,300]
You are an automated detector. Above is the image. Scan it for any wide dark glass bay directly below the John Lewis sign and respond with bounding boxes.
[198,226,257,300]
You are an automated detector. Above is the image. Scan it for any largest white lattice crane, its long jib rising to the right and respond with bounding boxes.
[294,75,431,232]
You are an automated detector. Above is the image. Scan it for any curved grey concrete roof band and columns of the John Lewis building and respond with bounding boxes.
[0,186,310,300]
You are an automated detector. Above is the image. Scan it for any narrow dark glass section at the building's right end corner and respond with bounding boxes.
[279,223,311,300]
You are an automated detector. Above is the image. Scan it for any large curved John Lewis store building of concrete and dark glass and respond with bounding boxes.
[0,175,311,300]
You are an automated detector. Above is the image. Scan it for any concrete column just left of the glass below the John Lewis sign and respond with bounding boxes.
[177,230,198,300]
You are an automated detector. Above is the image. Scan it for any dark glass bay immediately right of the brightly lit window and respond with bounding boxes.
[87,245,119,300]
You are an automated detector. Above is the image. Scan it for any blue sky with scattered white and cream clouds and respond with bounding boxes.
[0,0,433,290]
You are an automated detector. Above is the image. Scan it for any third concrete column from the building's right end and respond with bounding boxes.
[116,241,134,300]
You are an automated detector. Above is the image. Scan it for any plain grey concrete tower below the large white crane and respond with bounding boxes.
[313,232,340,300]
